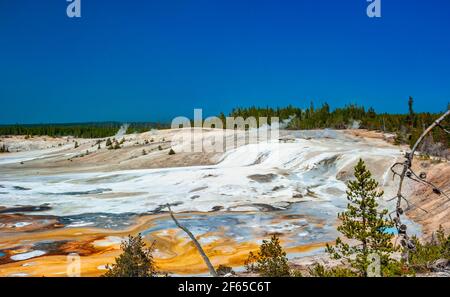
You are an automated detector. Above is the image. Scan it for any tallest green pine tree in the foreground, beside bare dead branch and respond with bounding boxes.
[327,159,394,276]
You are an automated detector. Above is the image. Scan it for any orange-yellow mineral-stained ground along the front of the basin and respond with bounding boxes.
[0,215,325,277]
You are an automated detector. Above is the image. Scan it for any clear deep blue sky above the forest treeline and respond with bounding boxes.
[0,0,450,123]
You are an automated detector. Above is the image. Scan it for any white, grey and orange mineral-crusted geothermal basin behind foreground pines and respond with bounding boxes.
[0,132,419,275]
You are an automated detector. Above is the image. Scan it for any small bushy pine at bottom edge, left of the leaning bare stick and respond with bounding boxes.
[104,234,157,277]
